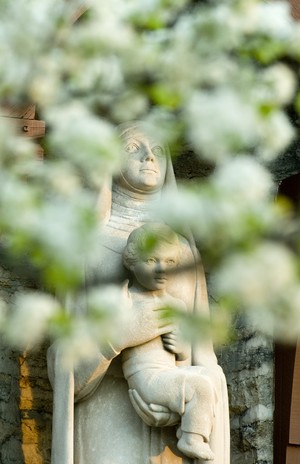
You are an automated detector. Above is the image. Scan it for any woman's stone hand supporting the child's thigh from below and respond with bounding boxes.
[128,390,180,427]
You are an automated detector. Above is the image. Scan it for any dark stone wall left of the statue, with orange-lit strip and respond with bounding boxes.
[0,267,52,464]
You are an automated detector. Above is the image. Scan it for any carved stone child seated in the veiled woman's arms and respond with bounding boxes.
[122,223,216,461]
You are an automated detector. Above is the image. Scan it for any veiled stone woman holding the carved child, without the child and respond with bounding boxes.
[48,122,229,464]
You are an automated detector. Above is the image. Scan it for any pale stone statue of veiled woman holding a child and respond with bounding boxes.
[48,122,230,464]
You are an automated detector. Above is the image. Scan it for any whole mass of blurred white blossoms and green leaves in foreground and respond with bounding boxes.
[0,0,300,356]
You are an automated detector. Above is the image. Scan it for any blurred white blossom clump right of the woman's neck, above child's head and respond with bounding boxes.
[156,165,283,246]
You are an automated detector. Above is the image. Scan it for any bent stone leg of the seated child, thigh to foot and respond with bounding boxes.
[128,366,216,461]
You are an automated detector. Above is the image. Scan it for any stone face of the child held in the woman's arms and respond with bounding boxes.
[130,244,179,291]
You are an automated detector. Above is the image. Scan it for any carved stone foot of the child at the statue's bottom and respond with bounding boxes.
[177,432,214,461]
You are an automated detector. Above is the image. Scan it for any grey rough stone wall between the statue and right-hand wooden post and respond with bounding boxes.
[219,320,274,464]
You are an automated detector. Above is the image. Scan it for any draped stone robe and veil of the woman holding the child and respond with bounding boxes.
[49,148,230,464]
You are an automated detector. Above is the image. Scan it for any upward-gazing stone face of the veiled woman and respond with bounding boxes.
[119,131,167,192]
